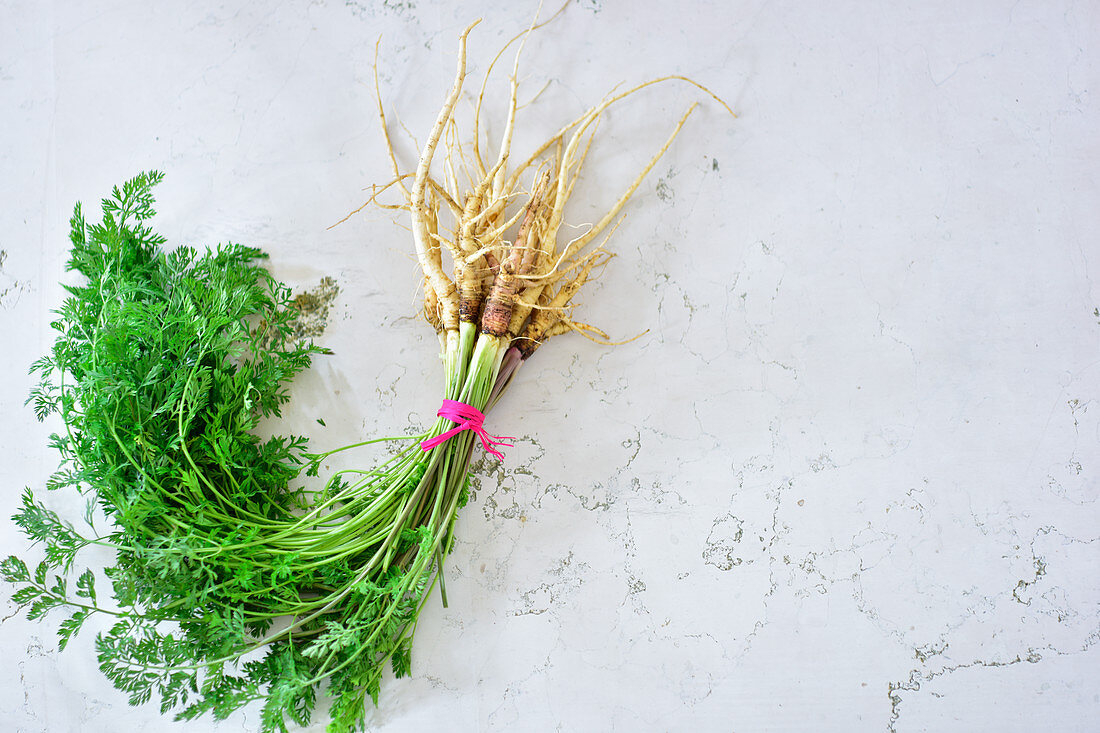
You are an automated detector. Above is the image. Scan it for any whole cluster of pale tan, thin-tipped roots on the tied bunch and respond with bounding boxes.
[375,23,733,376]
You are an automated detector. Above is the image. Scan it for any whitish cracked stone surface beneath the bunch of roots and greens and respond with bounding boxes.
[0,0,1100,733]
